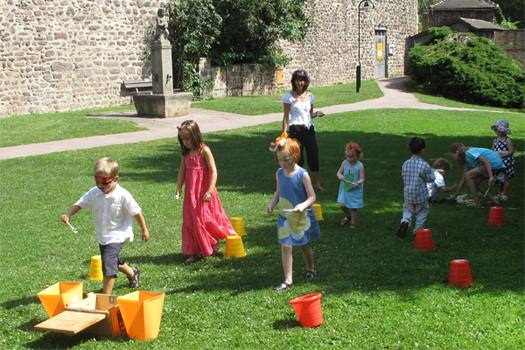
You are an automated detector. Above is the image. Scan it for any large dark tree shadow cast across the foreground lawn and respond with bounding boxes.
[112,130,523,293]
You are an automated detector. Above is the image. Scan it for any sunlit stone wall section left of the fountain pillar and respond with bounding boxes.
[0,0,165,116]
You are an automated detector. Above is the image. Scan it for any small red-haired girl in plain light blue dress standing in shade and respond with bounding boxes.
[337,142,365,229]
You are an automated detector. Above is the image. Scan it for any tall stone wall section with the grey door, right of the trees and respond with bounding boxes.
[280,0,418,89]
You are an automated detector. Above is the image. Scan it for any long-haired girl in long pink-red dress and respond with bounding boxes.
[176,120,237,264]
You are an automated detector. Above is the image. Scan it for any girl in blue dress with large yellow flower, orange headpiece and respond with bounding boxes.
[266,133,321,291]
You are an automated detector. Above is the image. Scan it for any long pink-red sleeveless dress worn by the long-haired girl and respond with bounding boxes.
[182,153,237,256]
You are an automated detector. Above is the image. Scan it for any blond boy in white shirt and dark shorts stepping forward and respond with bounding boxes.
[61,157,149,294]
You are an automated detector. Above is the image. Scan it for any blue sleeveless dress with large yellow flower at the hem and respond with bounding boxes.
[277,168,321,245]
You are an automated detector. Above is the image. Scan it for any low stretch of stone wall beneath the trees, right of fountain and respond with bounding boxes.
[199,58,277,97]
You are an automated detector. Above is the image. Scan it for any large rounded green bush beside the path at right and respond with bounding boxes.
[409,27,525,108]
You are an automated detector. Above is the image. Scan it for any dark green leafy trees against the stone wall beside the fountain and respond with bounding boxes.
[167,0,311,95]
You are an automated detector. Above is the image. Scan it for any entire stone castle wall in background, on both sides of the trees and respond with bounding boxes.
[0,0,418,116]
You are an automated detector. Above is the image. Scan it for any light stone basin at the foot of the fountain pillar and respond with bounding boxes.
[133,91,193,118]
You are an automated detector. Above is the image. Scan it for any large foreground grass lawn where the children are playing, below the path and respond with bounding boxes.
[0,109,525,350]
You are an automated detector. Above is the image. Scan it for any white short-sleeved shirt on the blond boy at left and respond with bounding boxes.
[77,183,141,245]
